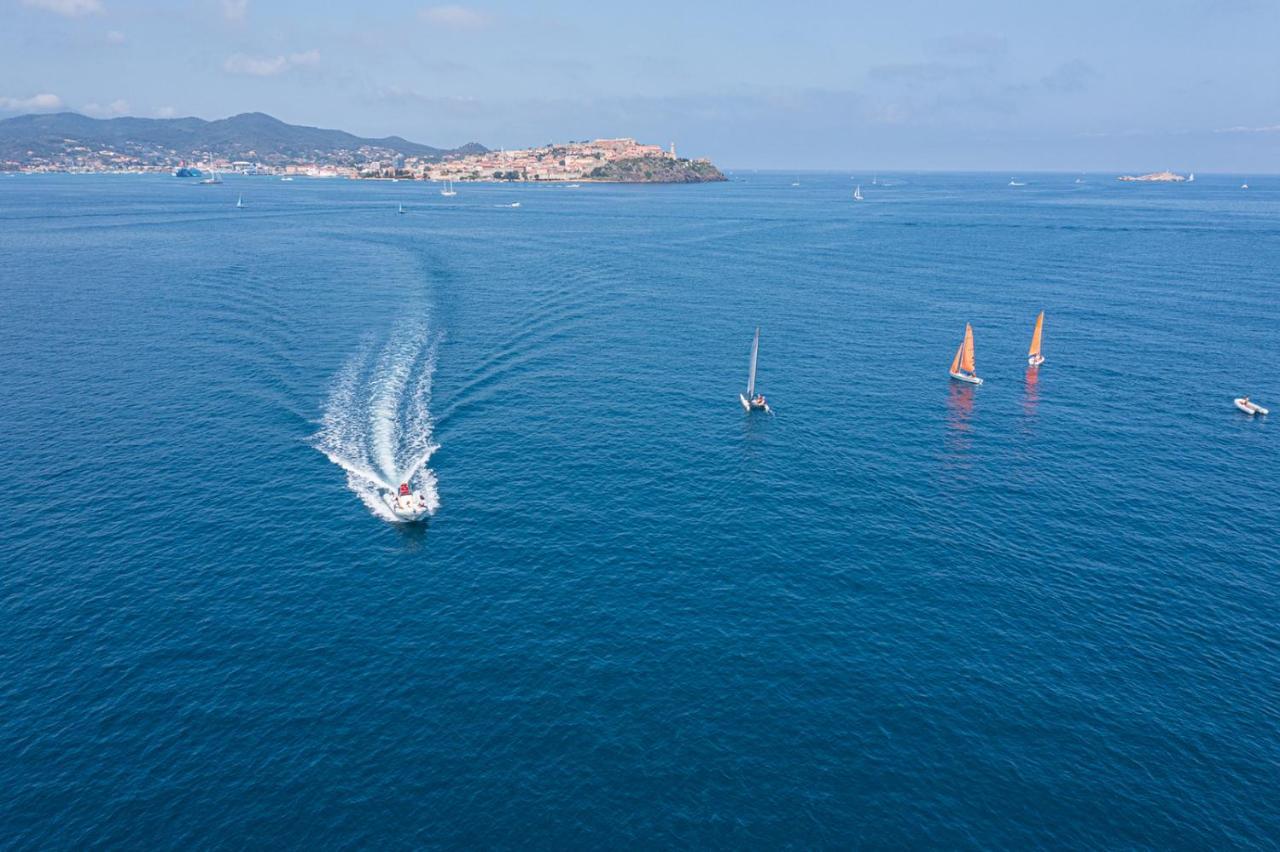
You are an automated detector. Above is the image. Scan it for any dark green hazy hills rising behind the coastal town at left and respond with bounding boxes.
[0,113,486,165]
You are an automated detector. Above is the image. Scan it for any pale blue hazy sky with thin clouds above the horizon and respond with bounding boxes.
[0,0,1280,173]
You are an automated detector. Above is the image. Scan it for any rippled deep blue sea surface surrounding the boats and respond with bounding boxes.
[0,173,1280,849]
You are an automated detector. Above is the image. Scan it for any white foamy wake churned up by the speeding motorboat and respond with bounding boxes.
[315,322,440,522]
